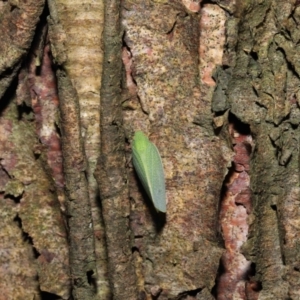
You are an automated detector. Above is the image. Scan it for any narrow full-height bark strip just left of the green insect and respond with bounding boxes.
[95,0,137,300]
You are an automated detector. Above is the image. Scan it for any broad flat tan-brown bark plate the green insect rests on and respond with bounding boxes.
[123,1,232,299]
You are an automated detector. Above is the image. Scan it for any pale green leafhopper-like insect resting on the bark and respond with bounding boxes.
[132,131,167,213]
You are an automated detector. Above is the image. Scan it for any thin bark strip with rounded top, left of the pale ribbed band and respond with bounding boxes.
[57,70,96,300]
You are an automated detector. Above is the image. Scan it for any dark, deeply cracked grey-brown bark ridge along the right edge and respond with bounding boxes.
[213,1,300,299]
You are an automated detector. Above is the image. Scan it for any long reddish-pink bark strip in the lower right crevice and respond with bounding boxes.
[217,120,255,300]
